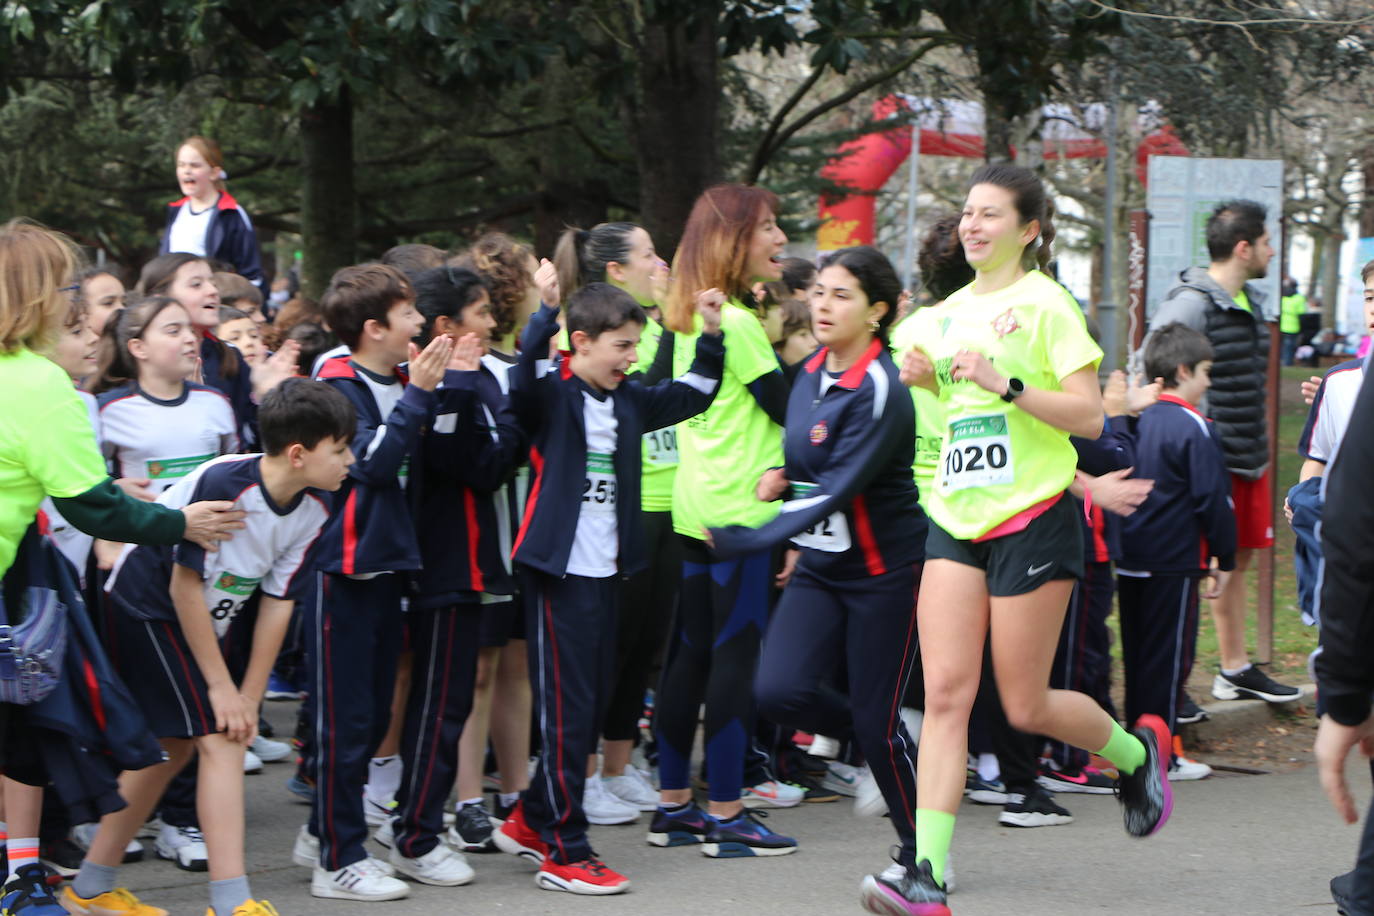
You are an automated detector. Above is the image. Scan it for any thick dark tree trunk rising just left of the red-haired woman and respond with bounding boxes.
[631,9,721,260]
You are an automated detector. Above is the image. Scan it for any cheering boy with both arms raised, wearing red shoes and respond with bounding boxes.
[495,269,724,894]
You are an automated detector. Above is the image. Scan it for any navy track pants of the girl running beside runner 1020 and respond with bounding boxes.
[754,564,921,865]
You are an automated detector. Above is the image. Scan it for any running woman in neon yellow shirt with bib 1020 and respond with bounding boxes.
[879,163,1173,916]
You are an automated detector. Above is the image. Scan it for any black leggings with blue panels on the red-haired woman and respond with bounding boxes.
[654,537,772,802]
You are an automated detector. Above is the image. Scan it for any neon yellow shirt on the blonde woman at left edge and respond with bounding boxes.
[0,349,109,574]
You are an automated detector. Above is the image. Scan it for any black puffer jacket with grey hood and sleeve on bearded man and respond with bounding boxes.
[1150,268,1270,479]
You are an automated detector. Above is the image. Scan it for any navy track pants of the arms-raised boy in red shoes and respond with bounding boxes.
[519,566,621,864]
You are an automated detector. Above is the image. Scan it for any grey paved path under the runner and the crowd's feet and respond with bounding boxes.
[125,705,1369,916]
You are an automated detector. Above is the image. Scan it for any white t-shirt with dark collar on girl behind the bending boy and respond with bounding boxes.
[99,382,239,493]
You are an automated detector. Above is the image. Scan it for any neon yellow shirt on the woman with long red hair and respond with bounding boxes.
[673,299,782,540]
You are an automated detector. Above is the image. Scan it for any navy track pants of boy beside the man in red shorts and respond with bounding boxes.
[1117,574,1198,735]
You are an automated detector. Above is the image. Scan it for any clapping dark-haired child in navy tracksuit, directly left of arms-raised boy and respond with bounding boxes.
[383,268,525,884]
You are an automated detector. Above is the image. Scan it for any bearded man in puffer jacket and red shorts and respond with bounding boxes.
[1150,201,1303,703]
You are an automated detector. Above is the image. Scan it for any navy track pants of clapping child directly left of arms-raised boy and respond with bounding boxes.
[394,603,482,858]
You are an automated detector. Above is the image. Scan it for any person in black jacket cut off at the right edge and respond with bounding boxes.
[1316,354,1374,916]
